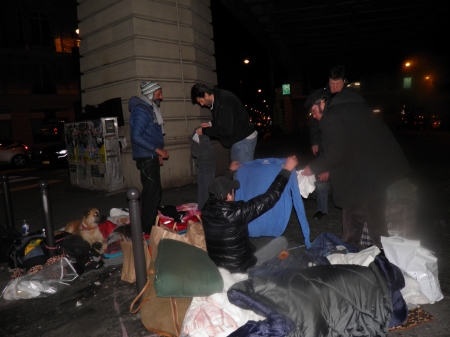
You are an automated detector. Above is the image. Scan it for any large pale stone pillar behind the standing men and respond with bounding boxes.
[78,0,227,188]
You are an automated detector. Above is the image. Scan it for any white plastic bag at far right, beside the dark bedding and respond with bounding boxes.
[381,236,444,302]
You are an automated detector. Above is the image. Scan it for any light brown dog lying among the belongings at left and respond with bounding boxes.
[64,208,106,254]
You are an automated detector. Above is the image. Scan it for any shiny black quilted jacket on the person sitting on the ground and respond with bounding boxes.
[202,169,291,273]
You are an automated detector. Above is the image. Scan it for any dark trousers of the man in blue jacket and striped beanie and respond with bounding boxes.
[136,156,162,233]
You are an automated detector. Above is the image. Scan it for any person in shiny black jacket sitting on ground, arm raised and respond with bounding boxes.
[202,156,298,273]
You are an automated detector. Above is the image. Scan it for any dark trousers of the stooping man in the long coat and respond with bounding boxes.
[341,191,389,248]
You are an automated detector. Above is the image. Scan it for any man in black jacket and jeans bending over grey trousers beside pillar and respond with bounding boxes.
[191,83,258,163]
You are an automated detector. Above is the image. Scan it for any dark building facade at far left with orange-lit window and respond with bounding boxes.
[0,0,80,145]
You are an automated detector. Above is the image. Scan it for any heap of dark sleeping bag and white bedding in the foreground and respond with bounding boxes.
[183,233,442,337]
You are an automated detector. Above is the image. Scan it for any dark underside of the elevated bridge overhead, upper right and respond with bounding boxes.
[220,0,450,85]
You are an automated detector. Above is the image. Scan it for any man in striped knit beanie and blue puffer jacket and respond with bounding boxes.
[128,81,169,233]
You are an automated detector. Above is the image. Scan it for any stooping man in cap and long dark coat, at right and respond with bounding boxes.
[302,89,410,248]
